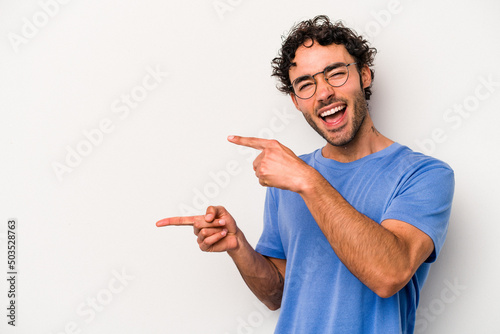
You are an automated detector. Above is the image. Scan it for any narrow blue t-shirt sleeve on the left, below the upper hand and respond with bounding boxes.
[255,188,286,259]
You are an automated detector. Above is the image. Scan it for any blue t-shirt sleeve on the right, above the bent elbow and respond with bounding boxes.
[382,163,455,263]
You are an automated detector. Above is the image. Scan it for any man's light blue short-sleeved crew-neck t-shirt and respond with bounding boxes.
[256,143,454,334]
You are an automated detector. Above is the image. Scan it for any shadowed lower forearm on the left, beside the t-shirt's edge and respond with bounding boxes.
[228,231,284,310]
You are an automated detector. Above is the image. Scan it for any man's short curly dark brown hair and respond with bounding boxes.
[271,15,377,100]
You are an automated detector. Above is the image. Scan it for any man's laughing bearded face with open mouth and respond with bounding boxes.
[289,42,371,146]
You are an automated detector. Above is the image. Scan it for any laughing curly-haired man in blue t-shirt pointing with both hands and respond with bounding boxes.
[157,16,454,334]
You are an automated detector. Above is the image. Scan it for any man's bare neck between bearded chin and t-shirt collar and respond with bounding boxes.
[322,113,394,162]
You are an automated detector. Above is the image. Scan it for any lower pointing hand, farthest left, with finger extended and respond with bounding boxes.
[156,206,239,252]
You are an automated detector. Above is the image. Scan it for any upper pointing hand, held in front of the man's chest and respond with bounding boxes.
[228,136,314,193]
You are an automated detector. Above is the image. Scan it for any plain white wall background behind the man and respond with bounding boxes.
[0,0,500,334]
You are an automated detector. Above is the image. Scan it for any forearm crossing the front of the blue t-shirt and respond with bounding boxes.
[300,168,410,296]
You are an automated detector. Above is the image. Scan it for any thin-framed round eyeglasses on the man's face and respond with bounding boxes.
[290,63,356,100]
